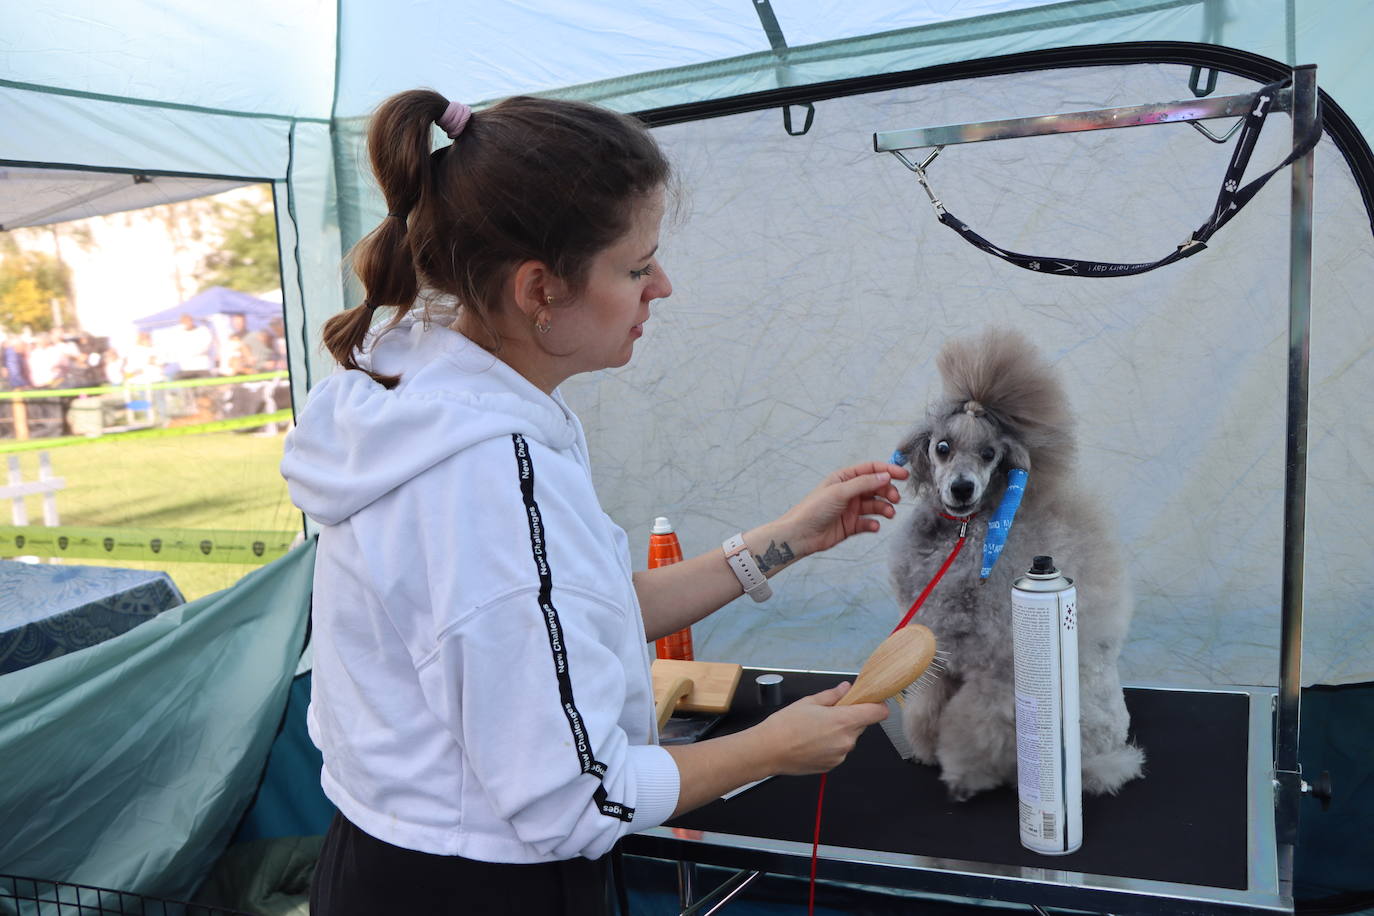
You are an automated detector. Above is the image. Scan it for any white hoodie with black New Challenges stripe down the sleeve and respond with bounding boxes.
[282,321,679,862]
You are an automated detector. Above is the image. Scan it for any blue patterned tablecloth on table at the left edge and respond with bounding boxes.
[0,560,185,674]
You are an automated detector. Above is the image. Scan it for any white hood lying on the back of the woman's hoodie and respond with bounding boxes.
[282,319,580,525]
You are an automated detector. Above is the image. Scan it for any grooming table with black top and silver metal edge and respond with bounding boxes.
[624,669,1292,916]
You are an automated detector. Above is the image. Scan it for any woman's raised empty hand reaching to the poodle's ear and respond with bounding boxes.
[778,461,911,559]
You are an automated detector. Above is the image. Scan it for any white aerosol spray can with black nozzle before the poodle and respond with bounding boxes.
[1011,556,1083,856]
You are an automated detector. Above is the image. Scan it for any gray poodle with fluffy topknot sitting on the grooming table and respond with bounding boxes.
[890,331,1145,801]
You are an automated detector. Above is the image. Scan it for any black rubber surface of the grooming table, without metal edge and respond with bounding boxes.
[669,669,1250,890]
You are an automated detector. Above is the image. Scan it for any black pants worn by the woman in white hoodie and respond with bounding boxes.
[311,813,614,916]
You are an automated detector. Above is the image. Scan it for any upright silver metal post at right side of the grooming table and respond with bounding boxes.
[1274,65,1318,895]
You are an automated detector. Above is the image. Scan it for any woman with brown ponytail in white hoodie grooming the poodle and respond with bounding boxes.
[282,91,907,916]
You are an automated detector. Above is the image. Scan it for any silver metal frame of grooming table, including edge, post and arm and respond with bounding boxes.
[643,65,1320,916]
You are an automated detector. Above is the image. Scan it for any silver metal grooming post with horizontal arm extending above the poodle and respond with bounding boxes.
[872,65,1318,897]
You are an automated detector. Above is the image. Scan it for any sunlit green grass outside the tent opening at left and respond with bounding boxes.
[0,433,301,600]
